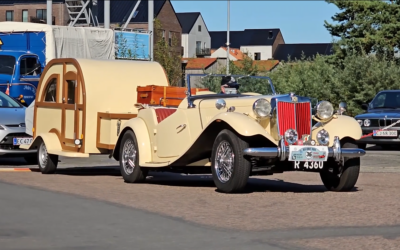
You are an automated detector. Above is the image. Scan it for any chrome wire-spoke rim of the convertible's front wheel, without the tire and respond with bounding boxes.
[214,141,235,183]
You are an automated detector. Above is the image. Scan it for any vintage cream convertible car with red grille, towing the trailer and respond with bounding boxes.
[110,75,365,193]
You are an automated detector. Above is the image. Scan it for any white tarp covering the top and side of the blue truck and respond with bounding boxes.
[0,22,115,63]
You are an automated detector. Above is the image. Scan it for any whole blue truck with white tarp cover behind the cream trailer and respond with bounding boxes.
[0,22,115,105]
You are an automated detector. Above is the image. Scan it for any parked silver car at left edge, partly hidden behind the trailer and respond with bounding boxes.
[0,91,37,164]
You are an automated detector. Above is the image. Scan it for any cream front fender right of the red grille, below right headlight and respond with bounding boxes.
[312,115,362,146]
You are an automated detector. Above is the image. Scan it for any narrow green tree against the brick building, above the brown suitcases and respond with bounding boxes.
[154,19,182,86]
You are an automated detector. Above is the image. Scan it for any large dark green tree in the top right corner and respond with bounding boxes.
[324,0,400,59]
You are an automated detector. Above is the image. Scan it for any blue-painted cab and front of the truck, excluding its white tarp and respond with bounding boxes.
[0,32,46,105]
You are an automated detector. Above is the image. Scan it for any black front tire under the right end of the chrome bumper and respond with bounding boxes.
[320,142,361,192]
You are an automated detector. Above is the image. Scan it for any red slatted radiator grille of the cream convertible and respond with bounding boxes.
[277,102,311,141]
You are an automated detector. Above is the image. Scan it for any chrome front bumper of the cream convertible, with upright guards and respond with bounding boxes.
[243,136,365,162]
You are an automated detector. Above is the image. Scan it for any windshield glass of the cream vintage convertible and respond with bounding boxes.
[194,75,274,95]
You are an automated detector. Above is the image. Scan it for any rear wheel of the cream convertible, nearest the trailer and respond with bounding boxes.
[119,130,148,183]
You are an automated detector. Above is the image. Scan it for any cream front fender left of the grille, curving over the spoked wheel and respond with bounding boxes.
[206,112,278,145]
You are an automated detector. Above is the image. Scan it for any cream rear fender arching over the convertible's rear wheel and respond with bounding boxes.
[110,117,151,165]
